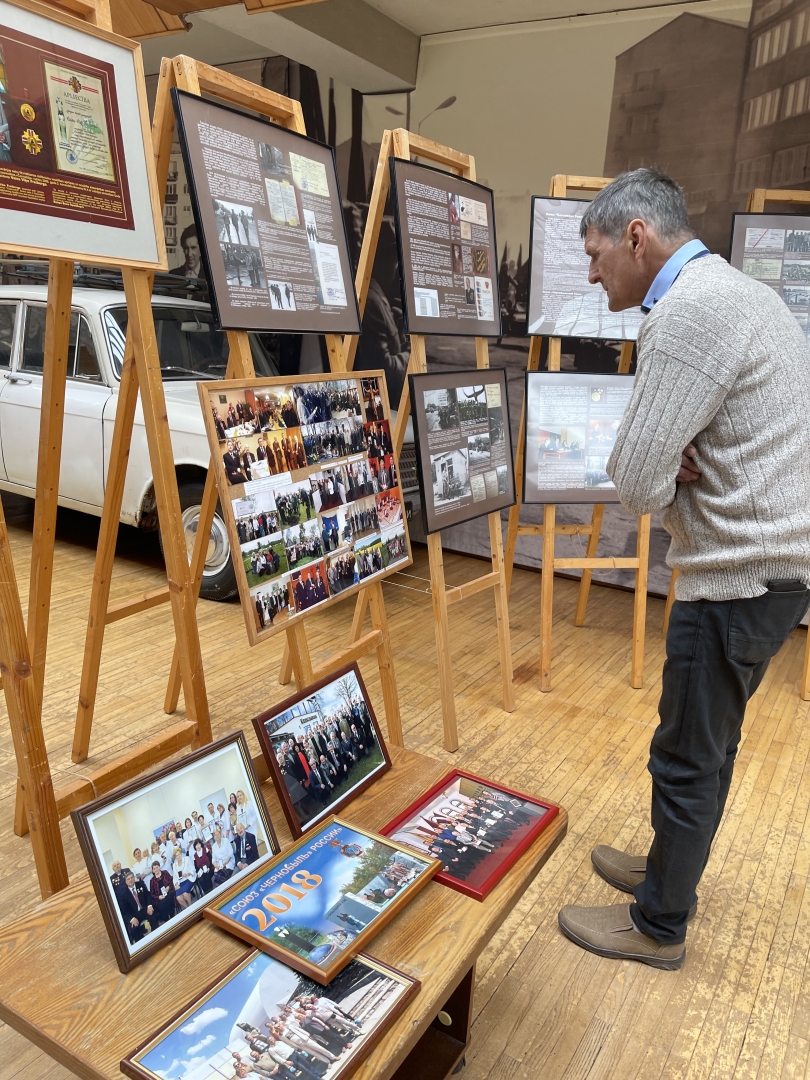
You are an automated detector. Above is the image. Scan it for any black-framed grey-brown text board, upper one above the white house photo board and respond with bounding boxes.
[389,158,501,337]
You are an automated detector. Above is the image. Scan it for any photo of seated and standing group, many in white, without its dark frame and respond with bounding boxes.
[87,742,274,953]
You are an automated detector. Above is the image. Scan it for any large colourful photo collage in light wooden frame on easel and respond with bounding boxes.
[198,370,411,645]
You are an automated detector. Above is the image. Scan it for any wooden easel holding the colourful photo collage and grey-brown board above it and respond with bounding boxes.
[130,56,403,746]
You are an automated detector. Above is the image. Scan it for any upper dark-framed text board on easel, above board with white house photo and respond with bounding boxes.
[388,157,502,338]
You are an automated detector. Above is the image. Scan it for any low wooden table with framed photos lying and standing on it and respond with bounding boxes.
[0,745,568,1080]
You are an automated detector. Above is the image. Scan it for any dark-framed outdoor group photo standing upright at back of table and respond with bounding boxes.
[253,661,391,838]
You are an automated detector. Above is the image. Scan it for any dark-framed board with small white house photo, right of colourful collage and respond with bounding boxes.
[408,367,516,534]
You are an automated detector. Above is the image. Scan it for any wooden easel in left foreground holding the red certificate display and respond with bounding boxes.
[0,0,211,895]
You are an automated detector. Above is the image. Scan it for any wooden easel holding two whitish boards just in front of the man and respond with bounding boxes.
[504,174,650,692]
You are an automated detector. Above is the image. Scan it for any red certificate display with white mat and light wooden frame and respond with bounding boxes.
[0,0,167,270]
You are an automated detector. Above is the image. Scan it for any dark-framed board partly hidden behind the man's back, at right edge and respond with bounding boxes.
[729,214,810,339]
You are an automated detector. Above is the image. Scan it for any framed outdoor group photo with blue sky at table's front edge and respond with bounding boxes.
[121,951,419,1080]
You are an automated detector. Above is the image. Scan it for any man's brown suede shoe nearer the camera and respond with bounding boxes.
[557,904,686,971]
